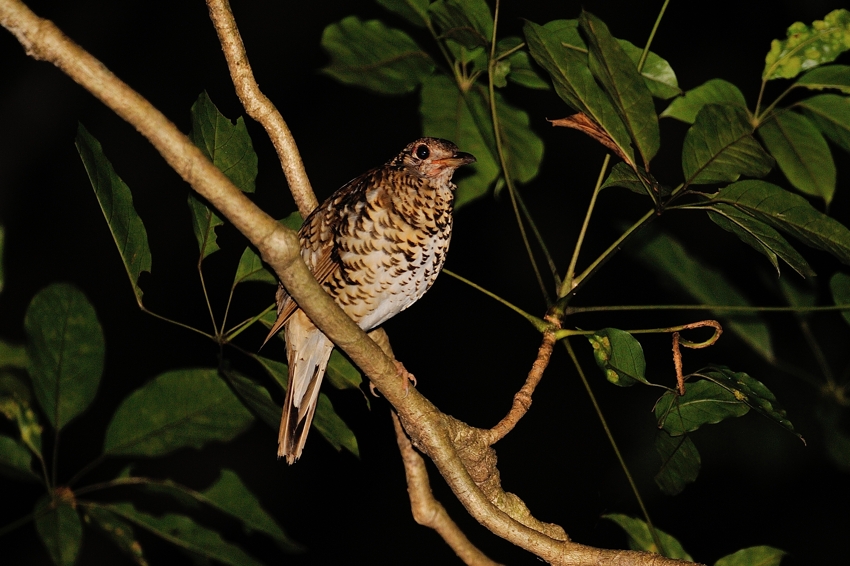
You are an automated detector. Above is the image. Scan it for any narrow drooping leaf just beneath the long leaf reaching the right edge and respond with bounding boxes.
[706,204,815,277]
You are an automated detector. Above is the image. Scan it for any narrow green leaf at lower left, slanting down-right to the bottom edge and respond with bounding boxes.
[101,503,263,566]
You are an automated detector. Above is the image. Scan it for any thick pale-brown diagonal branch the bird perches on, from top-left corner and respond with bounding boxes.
[0,0,690,565]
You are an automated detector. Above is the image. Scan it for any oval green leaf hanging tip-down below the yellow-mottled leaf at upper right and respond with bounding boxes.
[759,112,835,205]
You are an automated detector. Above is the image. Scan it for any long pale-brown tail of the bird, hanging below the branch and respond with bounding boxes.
[277,310,333,464]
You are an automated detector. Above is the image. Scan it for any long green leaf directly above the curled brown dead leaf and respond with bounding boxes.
[520,20,632,164]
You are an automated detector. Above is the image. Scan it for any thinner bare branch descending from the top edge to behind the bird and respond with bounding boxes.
[207,0,319,218]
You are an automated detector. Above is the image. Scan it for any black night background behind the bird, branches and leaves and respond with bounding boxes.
[0,0,850,565]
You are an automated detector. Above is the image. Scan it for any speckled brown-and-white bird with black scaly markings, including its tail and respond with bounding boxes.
[263,137,475,465]
